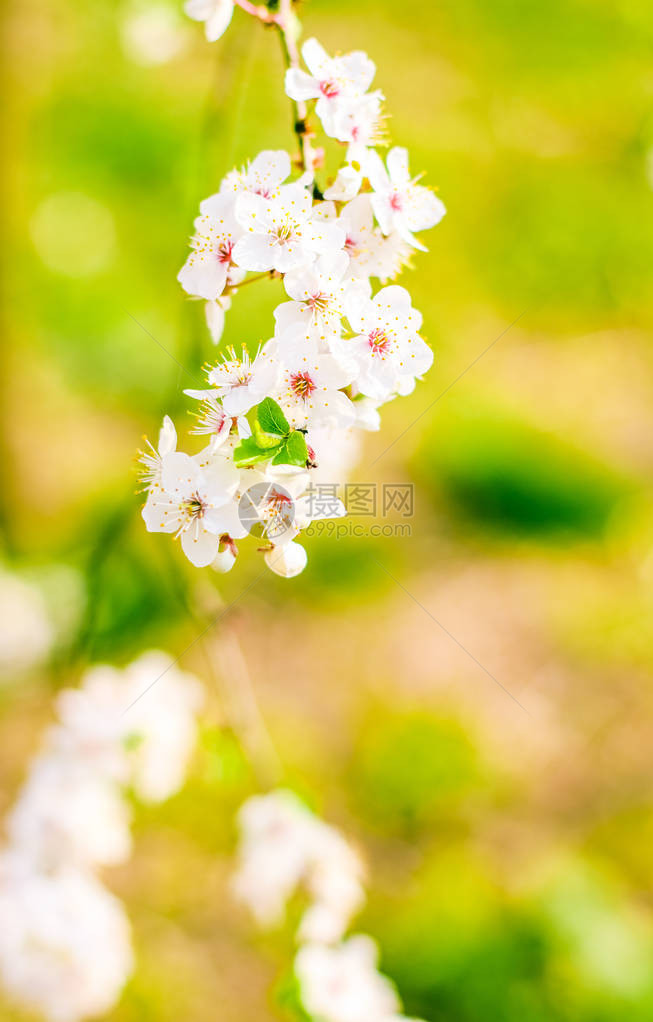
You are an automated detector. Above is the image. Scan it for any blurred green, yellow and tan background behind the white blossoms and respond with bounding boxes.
[0,0,653,1022]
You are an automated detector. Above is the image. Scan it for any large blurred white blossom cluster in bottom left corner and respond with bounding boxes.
[0,652,201,1022]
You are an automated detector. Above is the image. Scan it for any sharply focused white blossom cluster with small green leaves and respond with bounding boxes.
[142,33,445,576]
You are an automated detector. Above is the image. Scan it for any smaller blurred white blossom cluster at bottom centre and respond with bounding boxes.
[234,789,425,1022]
